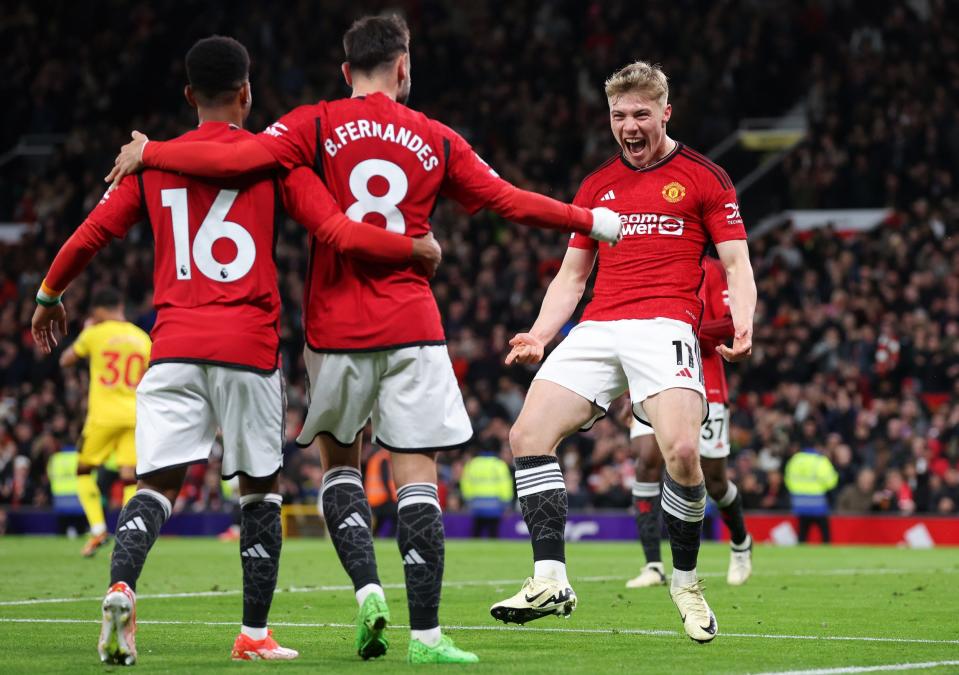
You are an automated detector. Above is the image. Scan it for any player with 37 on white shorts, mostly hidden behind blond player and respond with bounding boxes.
[626,256,753,588]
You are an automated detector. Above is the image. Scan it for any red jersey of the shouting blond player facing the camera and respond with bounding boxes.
[570,143,746,332]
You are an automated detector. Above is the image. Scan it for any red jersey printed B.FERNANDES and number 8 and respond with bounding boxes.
[257,93,504,351]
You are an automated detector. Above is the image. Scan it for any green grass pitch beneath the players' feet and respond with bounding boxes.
[0,537,959,674]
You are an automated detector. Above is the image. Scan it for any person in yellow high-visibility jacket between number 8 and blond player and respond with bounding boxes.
[460,442,513,539]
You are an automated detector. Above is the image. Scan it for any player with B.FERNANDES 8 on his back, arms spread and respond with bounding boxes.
[107,15,620,663]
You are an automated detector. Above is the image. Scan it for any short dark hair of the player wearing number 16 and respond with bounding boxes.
[186,35,250,105]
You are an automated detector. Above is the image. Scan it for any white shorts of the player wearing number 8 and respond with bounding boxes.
[296,345,473,452]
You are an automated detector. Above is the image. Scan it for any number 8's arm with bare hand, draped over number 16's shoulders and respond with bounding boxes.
[104,131,280,183]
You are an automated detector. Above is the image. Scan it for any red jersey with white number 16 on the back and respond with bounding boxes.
[88,122,280,371]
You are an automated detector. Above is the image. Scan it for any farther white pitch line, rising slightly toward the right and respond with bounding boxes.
[0,567,936,607]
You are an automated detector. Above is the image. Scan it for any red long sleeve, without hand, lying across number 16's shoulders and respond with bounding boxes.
[143,138,280,178]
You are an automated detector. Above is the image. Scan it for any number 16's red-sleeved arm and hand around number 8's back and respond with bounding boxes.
[282,167,442,277]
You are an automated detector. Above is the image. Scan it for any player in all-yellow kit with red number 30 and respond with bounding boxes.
[57,289,150,557]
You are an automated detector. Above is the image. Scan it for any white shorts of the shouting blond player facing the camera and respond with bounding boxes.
[535,318,706,430]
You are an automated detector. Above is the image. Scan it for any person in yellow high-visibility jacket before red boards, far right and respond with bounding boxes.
[785,445,839,544]
